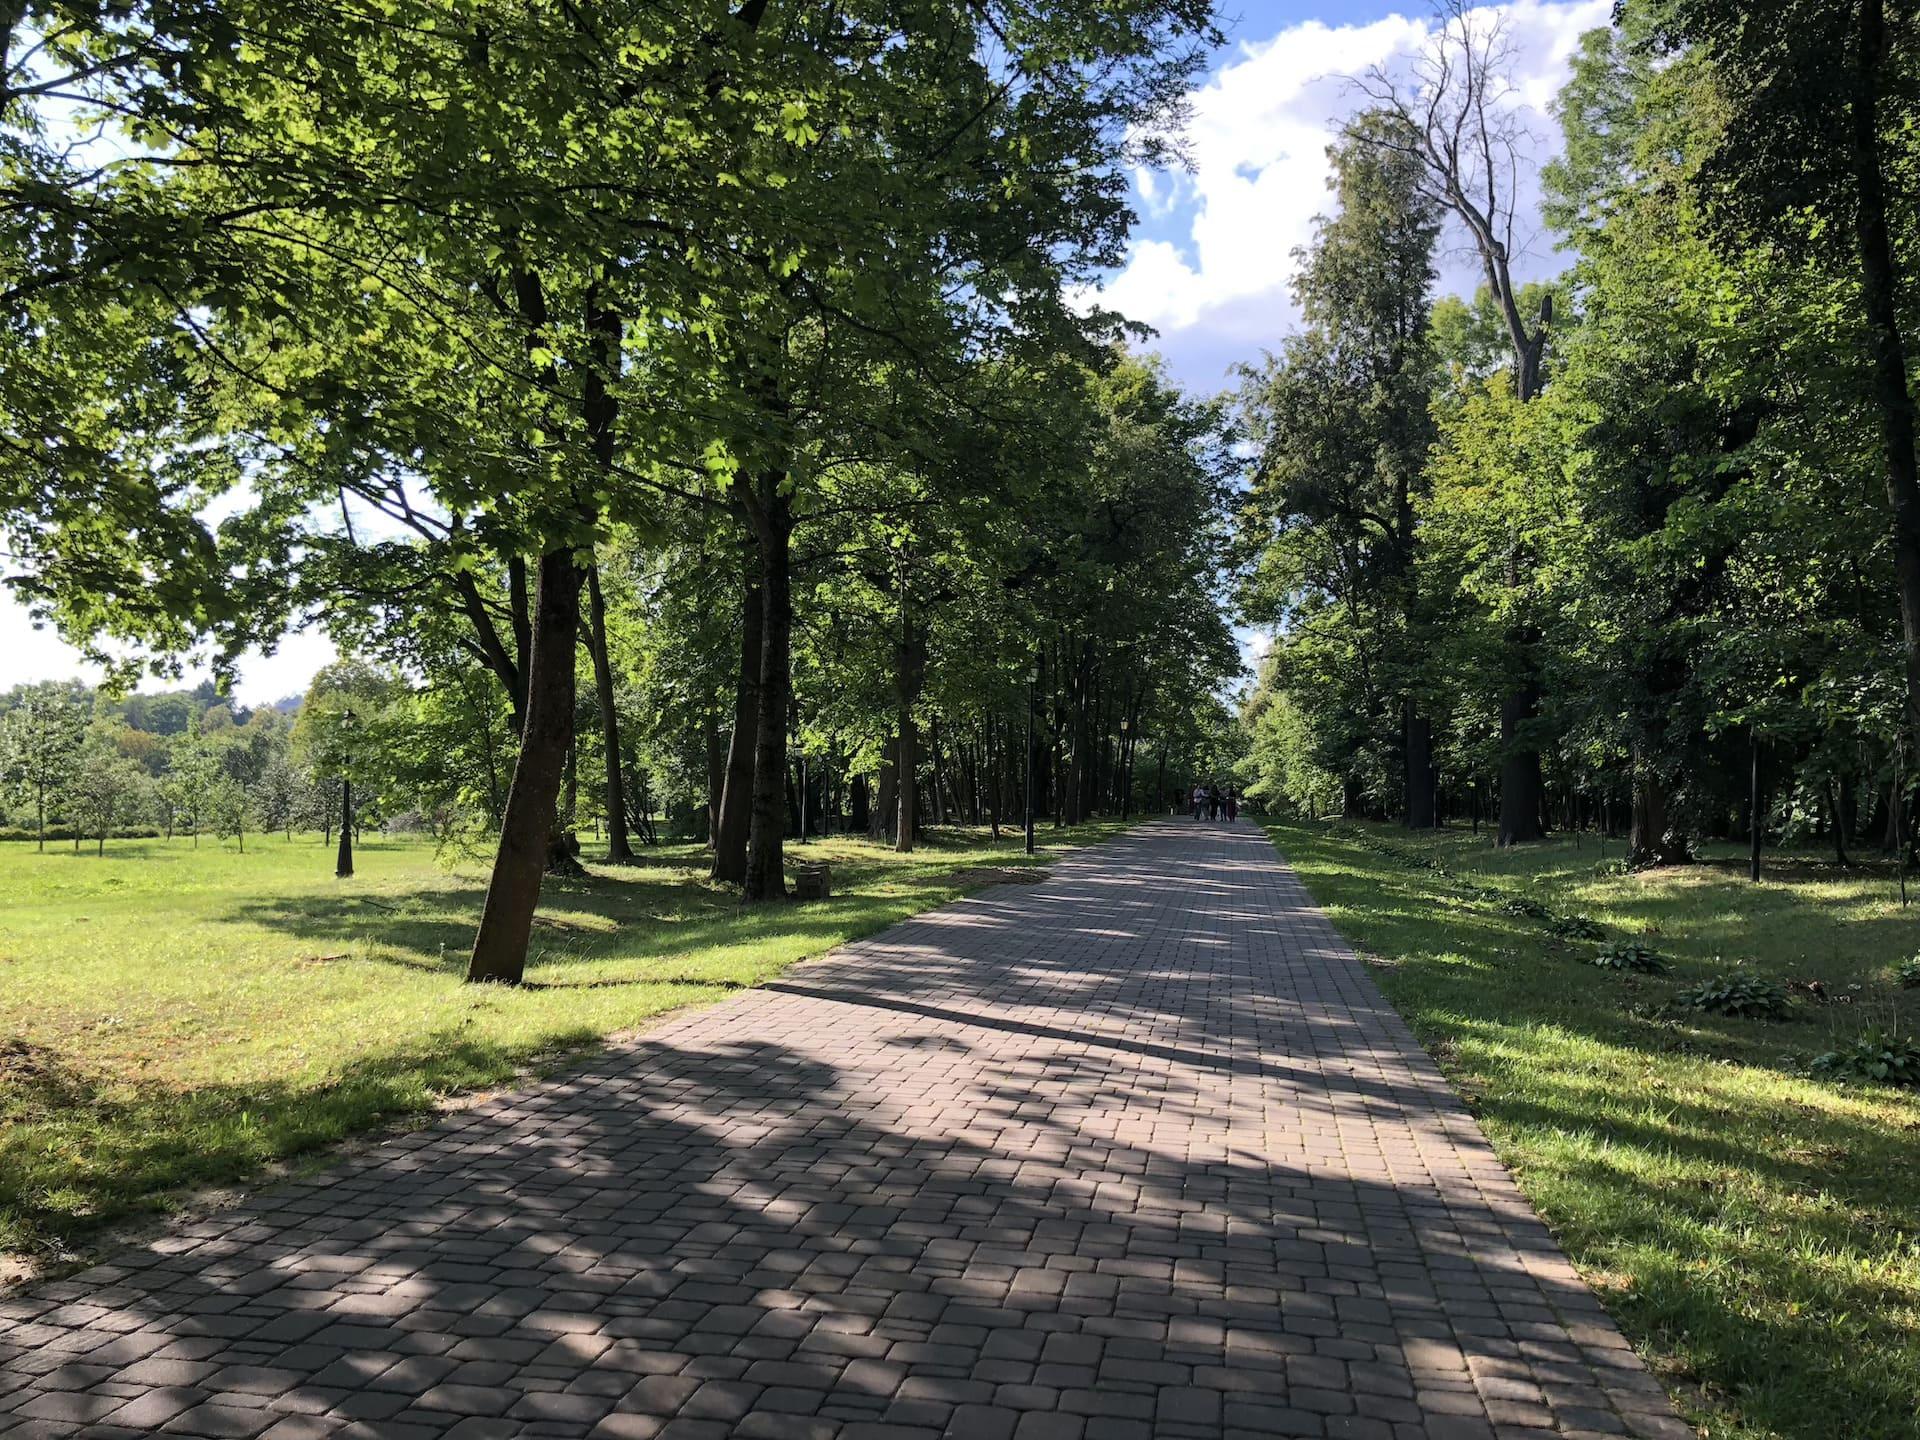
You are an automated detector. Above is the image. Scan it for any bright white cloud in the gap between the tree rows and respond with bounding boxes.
[1100,0,1611,380]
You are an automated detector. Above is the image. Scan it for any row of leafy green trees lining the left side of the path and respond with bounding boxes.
[0,0,1238,981]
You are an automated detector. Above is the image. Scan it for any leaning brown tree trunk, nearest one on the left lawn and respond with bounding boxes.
[467,549,582,985]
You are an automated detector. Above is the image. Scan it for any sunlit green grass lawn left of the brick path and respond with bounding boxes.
[0,826,1117,1267]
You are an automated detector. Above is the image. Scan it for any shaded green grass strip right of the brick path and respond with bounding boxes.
[1273,824,1920,1440]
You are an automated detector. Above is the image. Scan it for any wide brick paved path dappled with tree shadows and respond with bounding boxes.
[0,822,1690,1440]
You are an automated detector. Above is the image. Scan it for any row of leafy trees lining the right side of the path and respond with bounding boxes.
[1240,0,1920,864]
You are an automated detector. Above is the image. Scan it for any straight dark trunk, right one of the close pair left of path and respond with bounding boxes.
[743,485,793,900]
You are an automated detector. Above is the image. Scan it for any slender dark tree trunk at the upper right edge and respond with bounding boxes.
[1853,0,1920,771]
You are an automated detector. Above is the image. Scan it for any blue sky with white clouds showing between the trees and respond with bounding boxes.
[0,0,1611,705]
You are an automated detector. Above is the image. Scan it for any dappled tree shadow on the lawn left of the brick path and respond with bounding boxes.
[0,833,1121,1252]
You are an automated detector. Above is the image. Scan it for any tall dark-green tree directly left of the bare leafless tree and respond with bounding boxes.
[1242,111,1440,826]
